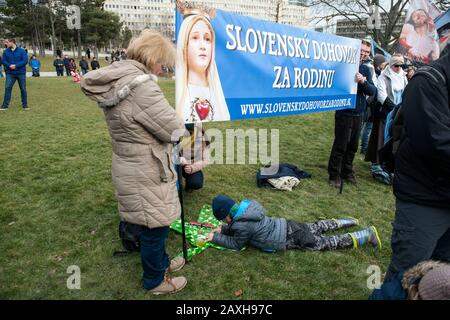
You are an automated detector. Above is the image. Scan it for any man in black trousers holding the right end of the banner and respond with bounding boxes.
[328,41,377,188]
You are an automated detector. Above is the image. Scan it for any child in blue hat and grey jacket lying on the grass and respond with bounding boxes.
[206,195,381,252]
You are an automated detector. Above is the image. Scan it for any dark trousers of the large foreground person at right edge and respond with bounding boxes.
[385,198,450,281]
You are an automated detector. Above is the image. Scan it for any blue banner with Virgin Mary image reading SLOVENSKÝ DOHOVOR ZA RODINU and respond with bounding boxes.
[176,8,361,123]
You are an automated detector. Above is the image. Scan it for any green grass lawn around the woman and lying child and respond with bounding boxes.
[0,78,394,300]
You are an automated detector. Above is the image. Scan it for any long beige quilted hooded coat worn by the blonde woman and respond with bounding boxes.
[81,60,184,228]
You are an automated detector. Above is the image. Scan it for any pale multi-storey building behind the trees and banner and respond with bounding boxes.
[104,0,310,39]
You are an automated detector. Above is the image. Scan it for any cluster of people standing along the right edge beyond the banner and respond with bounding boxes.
[328,36,450,299]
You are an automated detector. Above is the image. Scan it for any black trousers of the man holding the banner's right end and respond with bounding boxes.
[328,112,361,180]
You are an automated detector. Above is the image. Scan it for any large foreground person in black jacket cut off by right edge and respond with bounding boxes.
[385,45,450,282]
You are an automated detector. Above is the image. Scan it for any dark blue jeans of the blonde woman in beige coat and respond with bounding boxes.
[141,227,170,290]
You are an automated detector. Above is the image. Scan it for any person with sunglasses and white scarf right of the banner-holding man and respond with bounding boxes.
[364,55,408,185]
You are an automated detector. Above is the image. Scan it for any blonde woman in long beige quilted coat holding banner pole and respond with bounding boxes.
[81,29,187,294]
